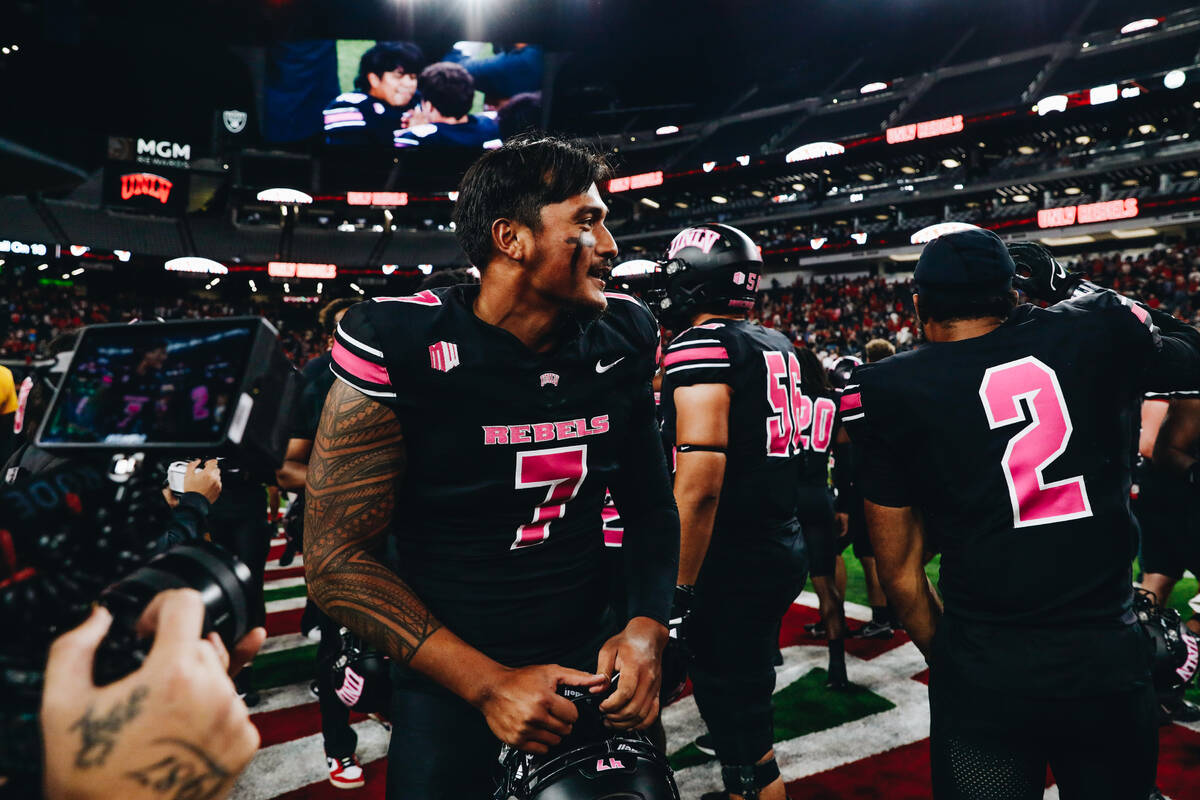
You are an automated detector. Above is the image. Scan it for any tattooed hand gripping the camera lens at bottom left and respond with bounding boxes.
[41,589,259,800]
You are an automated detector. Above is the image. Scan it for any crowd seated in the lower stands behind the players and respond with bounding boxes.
[0,243,1200,366]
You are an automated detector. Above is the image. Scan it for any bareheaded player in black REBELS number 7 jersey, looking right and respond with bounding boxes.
[305,138,679,800]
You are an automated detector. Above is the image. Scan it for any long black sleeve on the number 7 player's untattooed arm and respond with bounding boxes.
[608,386,679,625]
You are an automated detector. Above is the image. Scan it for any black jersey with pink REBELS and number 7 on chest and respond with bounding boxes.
[332,285,662,666]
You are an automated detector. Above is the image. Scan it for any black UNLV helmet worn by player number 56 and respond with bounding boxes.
[656,222,762,326]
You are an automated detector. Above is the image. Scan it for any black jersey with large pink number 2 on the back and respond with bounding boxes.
[841,291,1195,694]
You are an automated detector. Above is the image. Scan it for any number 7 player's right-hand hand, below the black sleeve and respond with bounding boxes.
[596,616,667,730]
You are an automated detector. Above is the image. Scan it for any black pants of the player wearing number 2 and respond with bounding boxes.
[929,666,1158,800]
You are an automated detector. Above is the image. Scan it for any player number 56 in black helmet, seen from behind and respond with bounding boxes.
[660,223,806,800]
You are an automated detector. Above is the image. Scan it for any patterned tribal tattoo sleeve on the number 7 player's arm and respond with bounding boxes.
[304,381,442,664]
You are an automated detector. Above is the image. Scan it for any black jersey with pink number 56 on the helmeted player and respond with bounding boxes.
[662,319,801,534]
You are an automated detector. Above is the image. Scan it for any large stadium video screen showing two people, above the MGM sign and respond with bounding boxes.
[264,40,545,152]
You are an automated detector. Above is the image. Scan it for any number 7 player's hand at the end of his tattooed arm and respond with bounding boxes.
[479,664,608,754]
